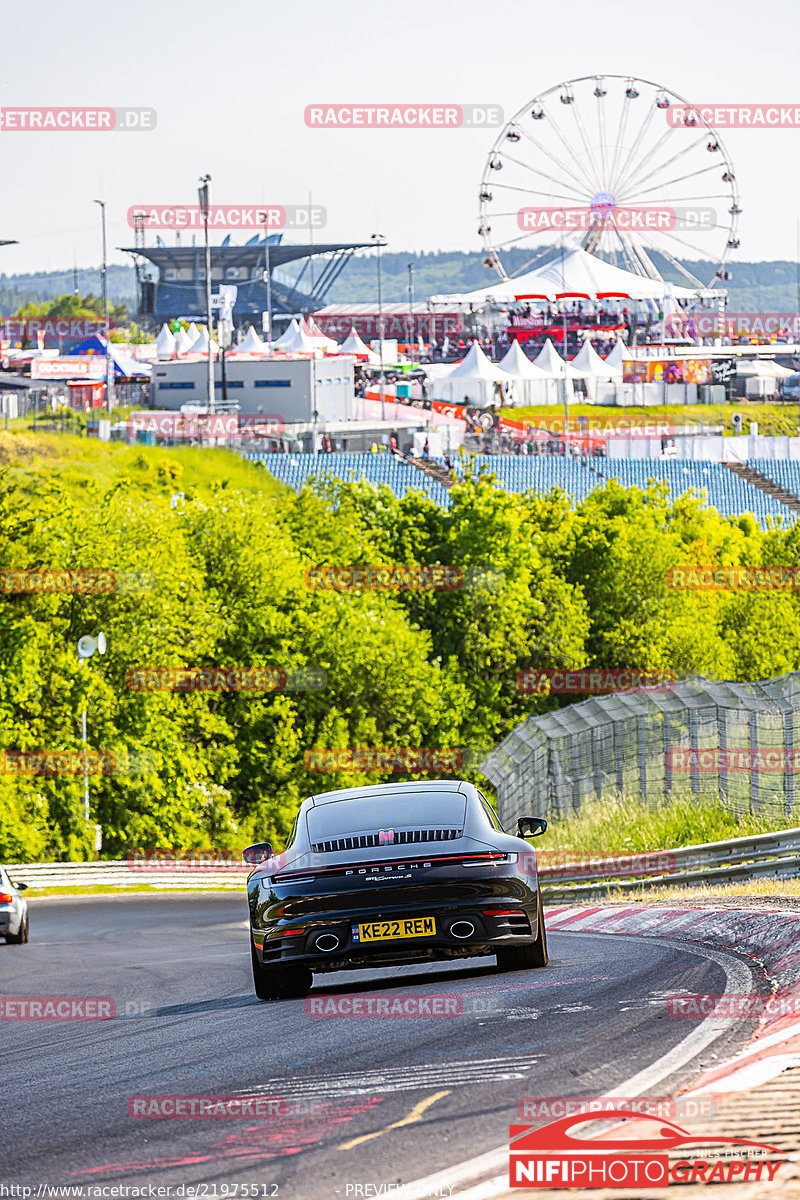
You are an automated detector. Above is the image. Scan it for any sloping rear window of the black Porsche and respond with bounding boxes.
[307,792,467,842]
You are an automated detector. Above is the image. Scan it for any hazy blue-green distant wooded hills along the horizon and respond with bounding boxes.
[0,250,798,316]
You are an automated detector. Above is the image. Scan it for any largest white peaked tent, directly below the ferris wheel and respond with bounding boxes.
[431,247,694,307]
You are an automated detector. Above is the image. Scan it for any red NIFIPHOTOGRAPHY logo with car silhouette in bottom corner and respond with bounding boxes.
[509,1109,786,1188]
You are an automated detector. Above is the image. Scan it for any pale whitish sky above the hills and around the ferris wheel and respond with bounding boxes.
[0,0,800,290]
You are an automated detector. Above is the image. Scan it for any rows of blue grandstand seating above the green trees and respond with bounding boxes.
[249,454,800,527]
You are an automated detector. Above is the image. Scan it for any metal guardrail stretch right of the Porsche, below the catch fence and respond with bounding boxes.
[539,829,800,899]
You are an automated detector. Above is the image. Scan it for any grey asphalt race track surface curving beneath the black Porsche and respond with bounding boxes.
[0,893,764,1200]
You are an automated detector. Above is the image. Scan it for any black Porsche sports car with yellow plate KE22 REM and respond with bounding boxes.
[245,780,547,1000]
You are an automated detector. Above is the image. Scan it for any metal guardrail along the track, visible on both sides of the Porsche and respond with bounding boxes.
[6,829,800,900]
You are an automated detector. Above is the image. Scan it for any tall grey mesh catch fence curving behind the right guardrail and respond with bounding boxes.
[481,672,800,828]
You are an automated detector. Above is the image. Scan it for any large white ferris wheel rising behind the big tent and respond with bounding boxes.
[479,76,741,288]
